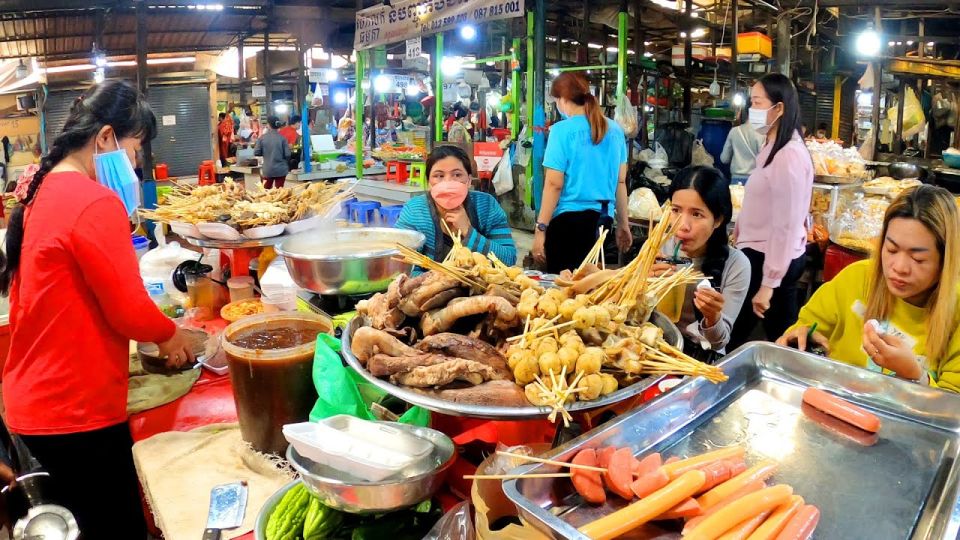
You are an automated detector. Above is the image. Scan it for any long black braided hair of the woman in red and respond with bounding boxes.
[0,81,157,295]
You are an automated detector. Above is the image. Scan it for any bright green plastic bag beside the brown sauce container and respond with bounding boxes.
[310,334,430,426]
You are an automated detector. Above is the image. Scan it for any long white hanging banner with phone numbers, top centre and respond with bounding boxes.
[353,0,524,51]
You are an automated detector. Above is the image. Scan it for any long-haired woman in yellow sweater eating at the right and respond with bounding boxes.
[777,186,960,392]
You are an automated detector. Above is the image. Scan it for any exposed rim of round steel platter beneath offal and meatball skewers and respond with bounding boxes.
[340,312,683,420]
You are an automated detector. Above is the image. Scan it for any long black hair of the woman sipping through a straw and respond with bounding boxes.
[670,165,733,285]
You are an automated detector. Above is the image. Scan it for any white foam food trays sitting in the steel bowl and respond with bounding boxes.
[283,414,433,482]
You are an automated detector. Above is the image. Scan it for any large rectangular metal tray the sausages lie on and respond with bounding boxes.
[503,343,960,540]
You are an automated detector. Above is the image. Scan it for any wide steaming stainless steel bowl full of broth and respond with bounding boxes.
[275,228,426,295]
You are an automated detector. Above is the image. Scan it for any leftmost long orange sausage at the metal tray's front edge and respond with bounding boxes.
[579,470,707,540]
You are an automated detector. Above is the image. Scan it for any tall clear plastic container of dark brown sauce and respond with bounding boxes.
[223,313,330,455]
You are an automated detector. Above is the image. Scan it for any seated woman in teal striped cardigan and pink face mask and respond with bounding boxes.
[396,144,517,265]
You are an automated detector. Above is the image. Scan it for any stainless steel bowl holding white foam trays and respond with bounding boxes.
[287,422,455,514]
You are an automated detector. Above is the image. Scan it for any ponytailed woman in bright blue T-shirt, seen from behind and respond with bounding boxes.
[533,73,632,274]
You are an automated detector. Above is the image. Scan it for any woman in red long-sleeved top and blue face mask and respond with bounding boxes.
[0,81,193,540]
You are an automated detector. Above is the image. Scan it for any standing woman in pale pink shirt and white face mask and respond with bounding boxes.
[730,73,813,349]
